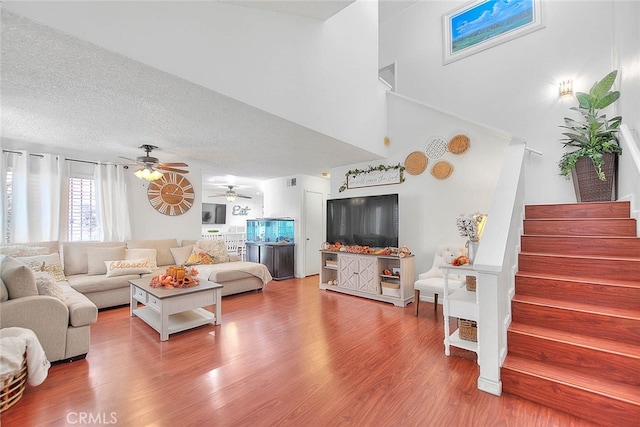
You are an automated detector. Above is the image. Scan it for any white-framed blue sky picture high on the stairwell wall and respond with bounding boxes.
[442,0,544,64]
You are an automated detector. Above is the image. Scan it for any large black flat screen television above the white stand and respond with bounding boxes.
[327,194,399,248]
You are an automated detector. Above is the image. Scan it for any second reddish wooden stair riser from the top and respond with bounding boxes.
[523,218,637,237]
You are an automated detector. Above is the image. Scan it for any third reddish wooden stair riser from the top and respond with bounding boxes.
[520,236,640,258]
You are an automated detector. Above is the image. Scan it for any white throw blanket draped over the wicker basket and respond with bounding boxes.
[0,328,51,387]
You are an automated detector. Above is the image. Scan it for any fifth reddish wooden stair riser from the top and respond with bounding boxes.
[516,274,640,310]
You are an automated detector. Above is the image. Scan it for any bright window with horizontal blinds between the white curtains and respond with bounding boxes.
[67,177,100,241]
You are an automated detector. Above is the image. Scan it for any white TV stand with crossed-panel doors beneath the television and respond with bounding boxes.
[320,251,415,307]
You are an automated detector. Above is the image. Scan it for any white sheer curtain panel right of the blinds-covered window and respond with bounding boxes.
[94,163,131,242]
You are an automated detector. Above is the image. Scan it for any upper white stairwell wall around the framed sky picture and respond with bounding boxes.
[380,0,640,207]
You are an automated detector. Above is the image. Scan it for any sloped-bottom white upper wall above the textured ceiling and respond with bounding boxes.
[3,1,386,154]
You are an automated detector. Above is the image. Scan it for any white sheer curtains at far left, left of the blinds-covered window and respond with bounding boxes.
[7,151,67,243]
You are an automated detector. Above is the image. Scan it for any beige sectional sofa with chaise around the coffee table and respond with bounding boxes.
[0,239,271,362]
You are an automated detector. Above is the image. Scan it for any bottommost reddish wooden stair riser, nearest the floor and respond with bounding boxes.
[501,368,640,426]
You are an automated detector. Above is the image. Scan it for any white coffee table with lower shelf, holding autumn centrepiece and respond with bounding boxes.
[129,277,222,341]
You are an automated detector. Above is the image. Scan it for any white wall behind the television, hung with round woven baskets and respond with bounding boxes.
[329,94,511,274]
